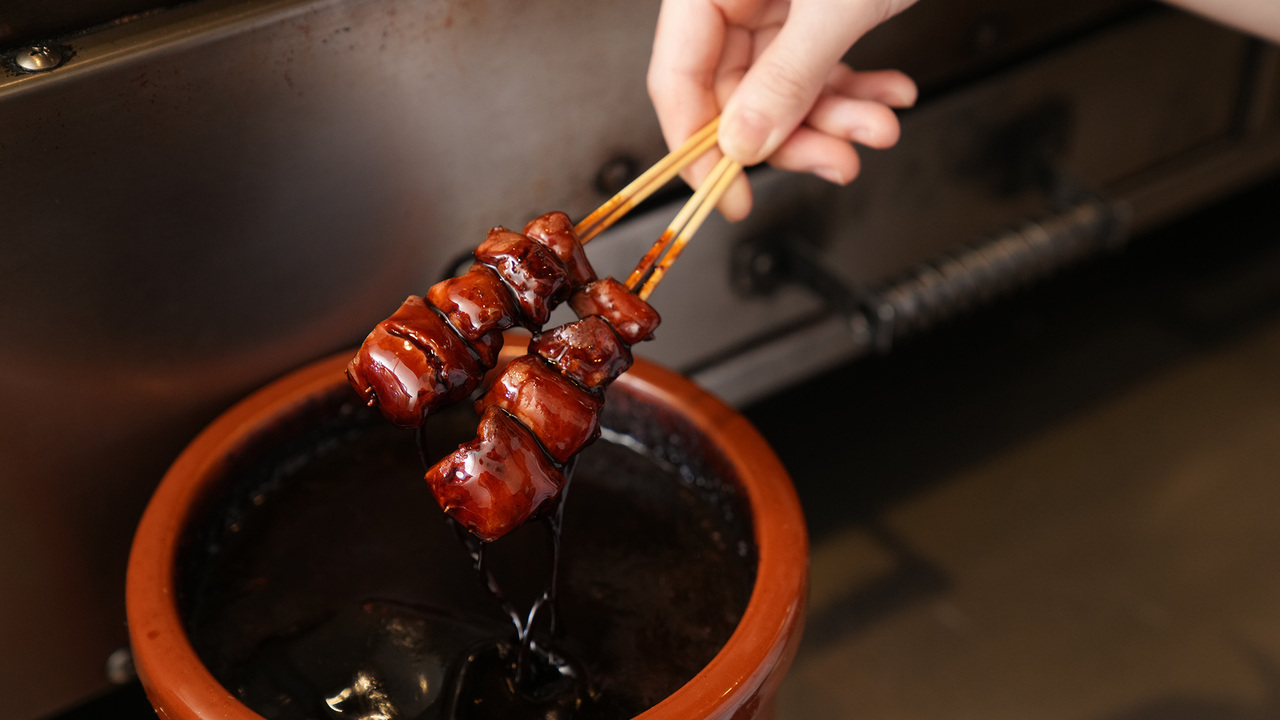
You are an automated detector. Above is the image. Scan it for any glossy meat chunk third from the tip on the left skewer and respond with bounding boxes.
[475,228,570,329]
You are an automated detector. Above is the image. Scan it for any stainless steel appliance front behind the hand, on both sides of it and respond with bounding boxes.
[0,0,1280,719]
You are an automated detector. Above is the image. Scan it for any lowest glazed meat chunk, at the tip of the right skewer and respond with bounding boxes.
[426,407,564,541]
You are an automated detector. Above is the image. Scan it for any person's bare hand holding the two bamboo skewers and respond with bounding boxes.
[648,0,916,220]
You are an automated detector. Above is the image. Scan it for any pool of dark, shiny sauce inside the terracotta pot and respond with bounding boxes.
[179,392,755,720]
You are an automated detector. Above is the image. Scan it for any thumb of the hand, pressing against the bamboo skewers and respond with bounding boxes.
[719,0,887,165]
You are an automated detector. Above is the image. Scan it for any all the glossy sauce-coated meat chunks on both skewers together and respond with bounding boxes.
[347,213,660,541]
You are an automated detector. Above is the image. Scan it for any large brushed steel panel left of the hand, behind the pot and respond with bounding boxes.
[0,0,663,719]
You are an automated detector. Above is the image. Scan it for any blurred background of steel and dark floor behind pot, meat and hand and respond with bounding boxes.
[0,0,1280,720]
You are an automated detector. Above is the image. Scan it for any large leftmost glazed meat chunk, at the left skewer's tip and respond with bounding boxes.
[347,295,481,428]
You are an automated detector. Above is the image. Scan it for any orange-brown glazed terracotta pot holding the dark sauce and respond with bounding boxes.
[127,341,808,720]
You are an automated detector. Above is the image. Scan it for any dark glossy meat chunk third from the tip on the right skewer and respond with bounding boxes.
[529,315,631,388]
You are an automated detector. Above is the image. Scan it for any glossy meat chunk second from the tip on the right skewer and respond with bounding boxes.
[476,355,600,462]
